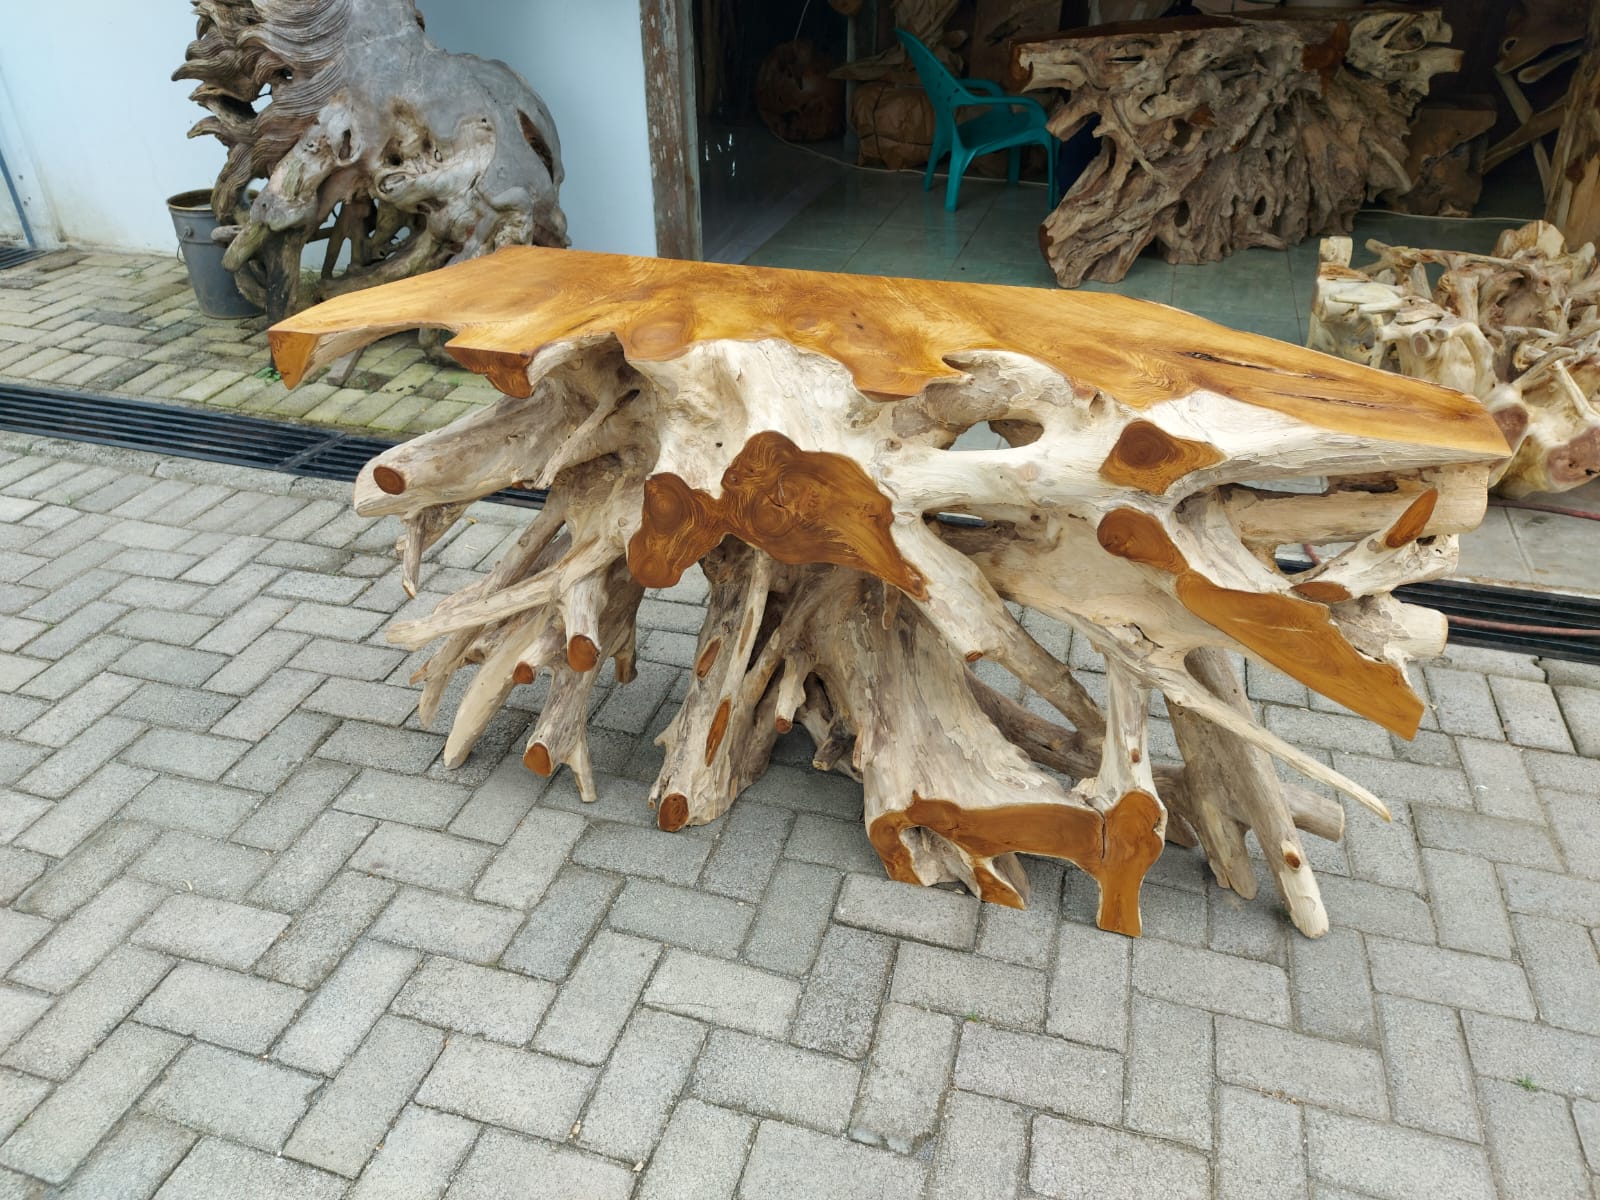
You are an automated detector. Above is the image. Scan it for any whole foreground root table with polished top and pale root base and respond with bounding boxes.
[272,250,1506,936]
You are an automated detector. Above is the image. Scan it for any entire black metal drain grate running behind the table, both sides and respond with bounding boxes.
[0,384,1600,662]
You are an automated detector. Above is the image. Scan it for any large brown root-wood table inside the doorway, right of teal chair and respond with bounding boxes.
[1013,10,1461,288]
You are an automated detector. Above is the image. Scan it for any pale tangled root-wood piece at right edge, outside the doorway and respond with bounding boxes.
[1307,221,1600,496]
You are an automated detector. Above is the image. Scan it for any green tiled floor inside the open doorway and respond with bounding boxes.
[746,162,1542,342]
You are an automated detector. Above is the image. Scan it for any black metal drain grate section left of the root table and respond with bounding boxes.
[0,384,544,507]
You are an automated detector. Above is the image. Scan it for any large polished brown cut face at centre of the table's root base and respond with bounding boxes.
[627,430,928,598]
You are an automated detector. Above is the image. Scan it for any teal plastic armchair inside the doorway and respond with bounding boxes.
[894,29,1058,213]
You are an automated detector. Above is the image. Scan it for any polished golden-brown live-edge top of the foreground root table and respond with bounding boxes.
[269,246,1504,454]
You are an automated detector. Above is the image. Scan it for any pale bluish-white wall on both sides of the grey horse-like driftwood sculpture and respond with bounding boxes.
[0,0,656,254]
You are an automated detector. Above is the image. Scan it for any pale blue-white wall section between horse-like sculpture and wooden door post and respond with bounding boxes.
[418,0,656,254]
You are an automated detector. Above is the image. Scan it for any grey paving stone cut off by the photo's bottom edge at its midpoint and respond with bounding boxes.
[739,1122,928,1200]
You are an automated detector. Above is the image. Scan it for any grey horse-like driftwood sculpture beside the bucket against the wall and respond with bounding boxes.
[173,0,566,318]
